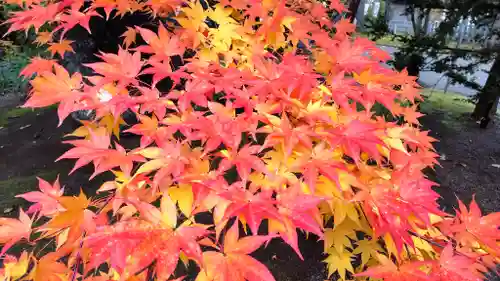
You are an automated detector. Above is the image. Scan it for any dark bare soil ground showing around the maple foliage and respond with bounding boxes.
[0,91,500,281]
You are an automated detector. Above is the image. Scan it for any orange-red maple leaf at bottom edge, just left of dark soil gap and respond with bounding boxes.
[195,221,275,281]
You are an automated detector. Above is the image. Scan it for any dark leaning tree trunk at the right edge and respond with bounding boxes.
[472,56,500,120]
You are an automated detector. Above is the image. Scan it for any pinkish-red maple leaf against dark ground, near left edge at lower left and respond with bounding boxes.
[16,176,64,216]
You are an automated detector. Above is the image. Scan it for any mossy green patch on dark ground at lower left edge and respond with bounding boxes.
[0,171,57,211]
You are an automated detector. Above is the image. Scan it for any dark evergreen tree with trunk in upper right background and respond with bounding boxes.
[368,0,500,124]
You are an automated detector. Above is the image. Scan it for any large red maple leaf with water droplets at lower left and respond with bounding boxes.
[85,219,207,279]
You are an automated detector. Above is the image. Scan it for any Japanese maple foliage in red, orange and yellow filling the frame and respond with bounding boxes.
[0,0,500,281]
